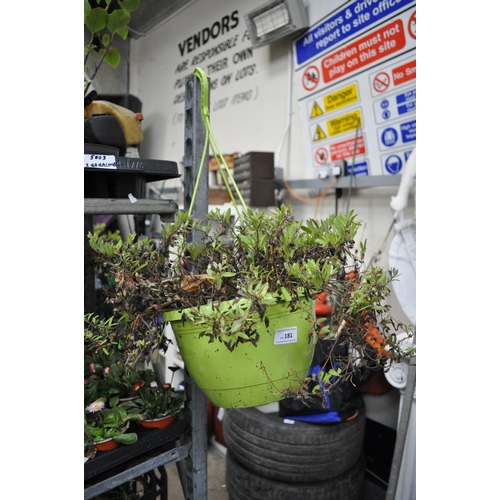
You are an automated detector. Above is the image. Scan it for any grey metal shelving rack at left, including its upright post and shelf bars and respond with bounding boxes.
[84,75,209,500]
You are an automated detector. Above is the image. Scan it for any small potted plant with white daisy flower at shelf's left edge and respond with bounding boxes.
[84,398,140,451]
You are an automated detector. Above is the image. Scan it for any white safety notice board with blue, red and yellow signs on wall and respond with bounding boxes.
[294,0,417,178]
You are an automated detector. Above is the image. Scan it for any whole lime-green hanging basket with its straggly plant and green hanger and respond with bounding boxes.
[85,68,412,408]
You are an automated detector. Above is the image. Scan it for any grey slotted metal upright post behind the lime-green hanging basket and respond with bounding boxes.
[177,74,209,500]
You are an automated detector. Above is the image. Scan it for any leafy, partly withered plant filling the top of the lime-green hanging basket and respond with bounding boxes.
[85,206,360,352]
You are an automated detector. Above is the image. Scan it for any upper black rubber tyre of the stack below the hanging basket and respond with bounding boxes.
[223,407,366,483]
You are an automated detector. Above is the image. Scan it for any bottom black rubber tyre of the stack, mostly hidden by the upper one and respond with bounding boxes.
[226,450,365,500]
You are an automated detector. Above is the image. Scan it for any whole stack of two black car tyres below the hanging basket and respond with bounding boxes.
[223,407,366,500]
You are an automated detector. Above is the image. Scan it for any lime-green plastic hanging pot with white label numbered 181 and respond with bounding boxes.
[164,299,315,408]
